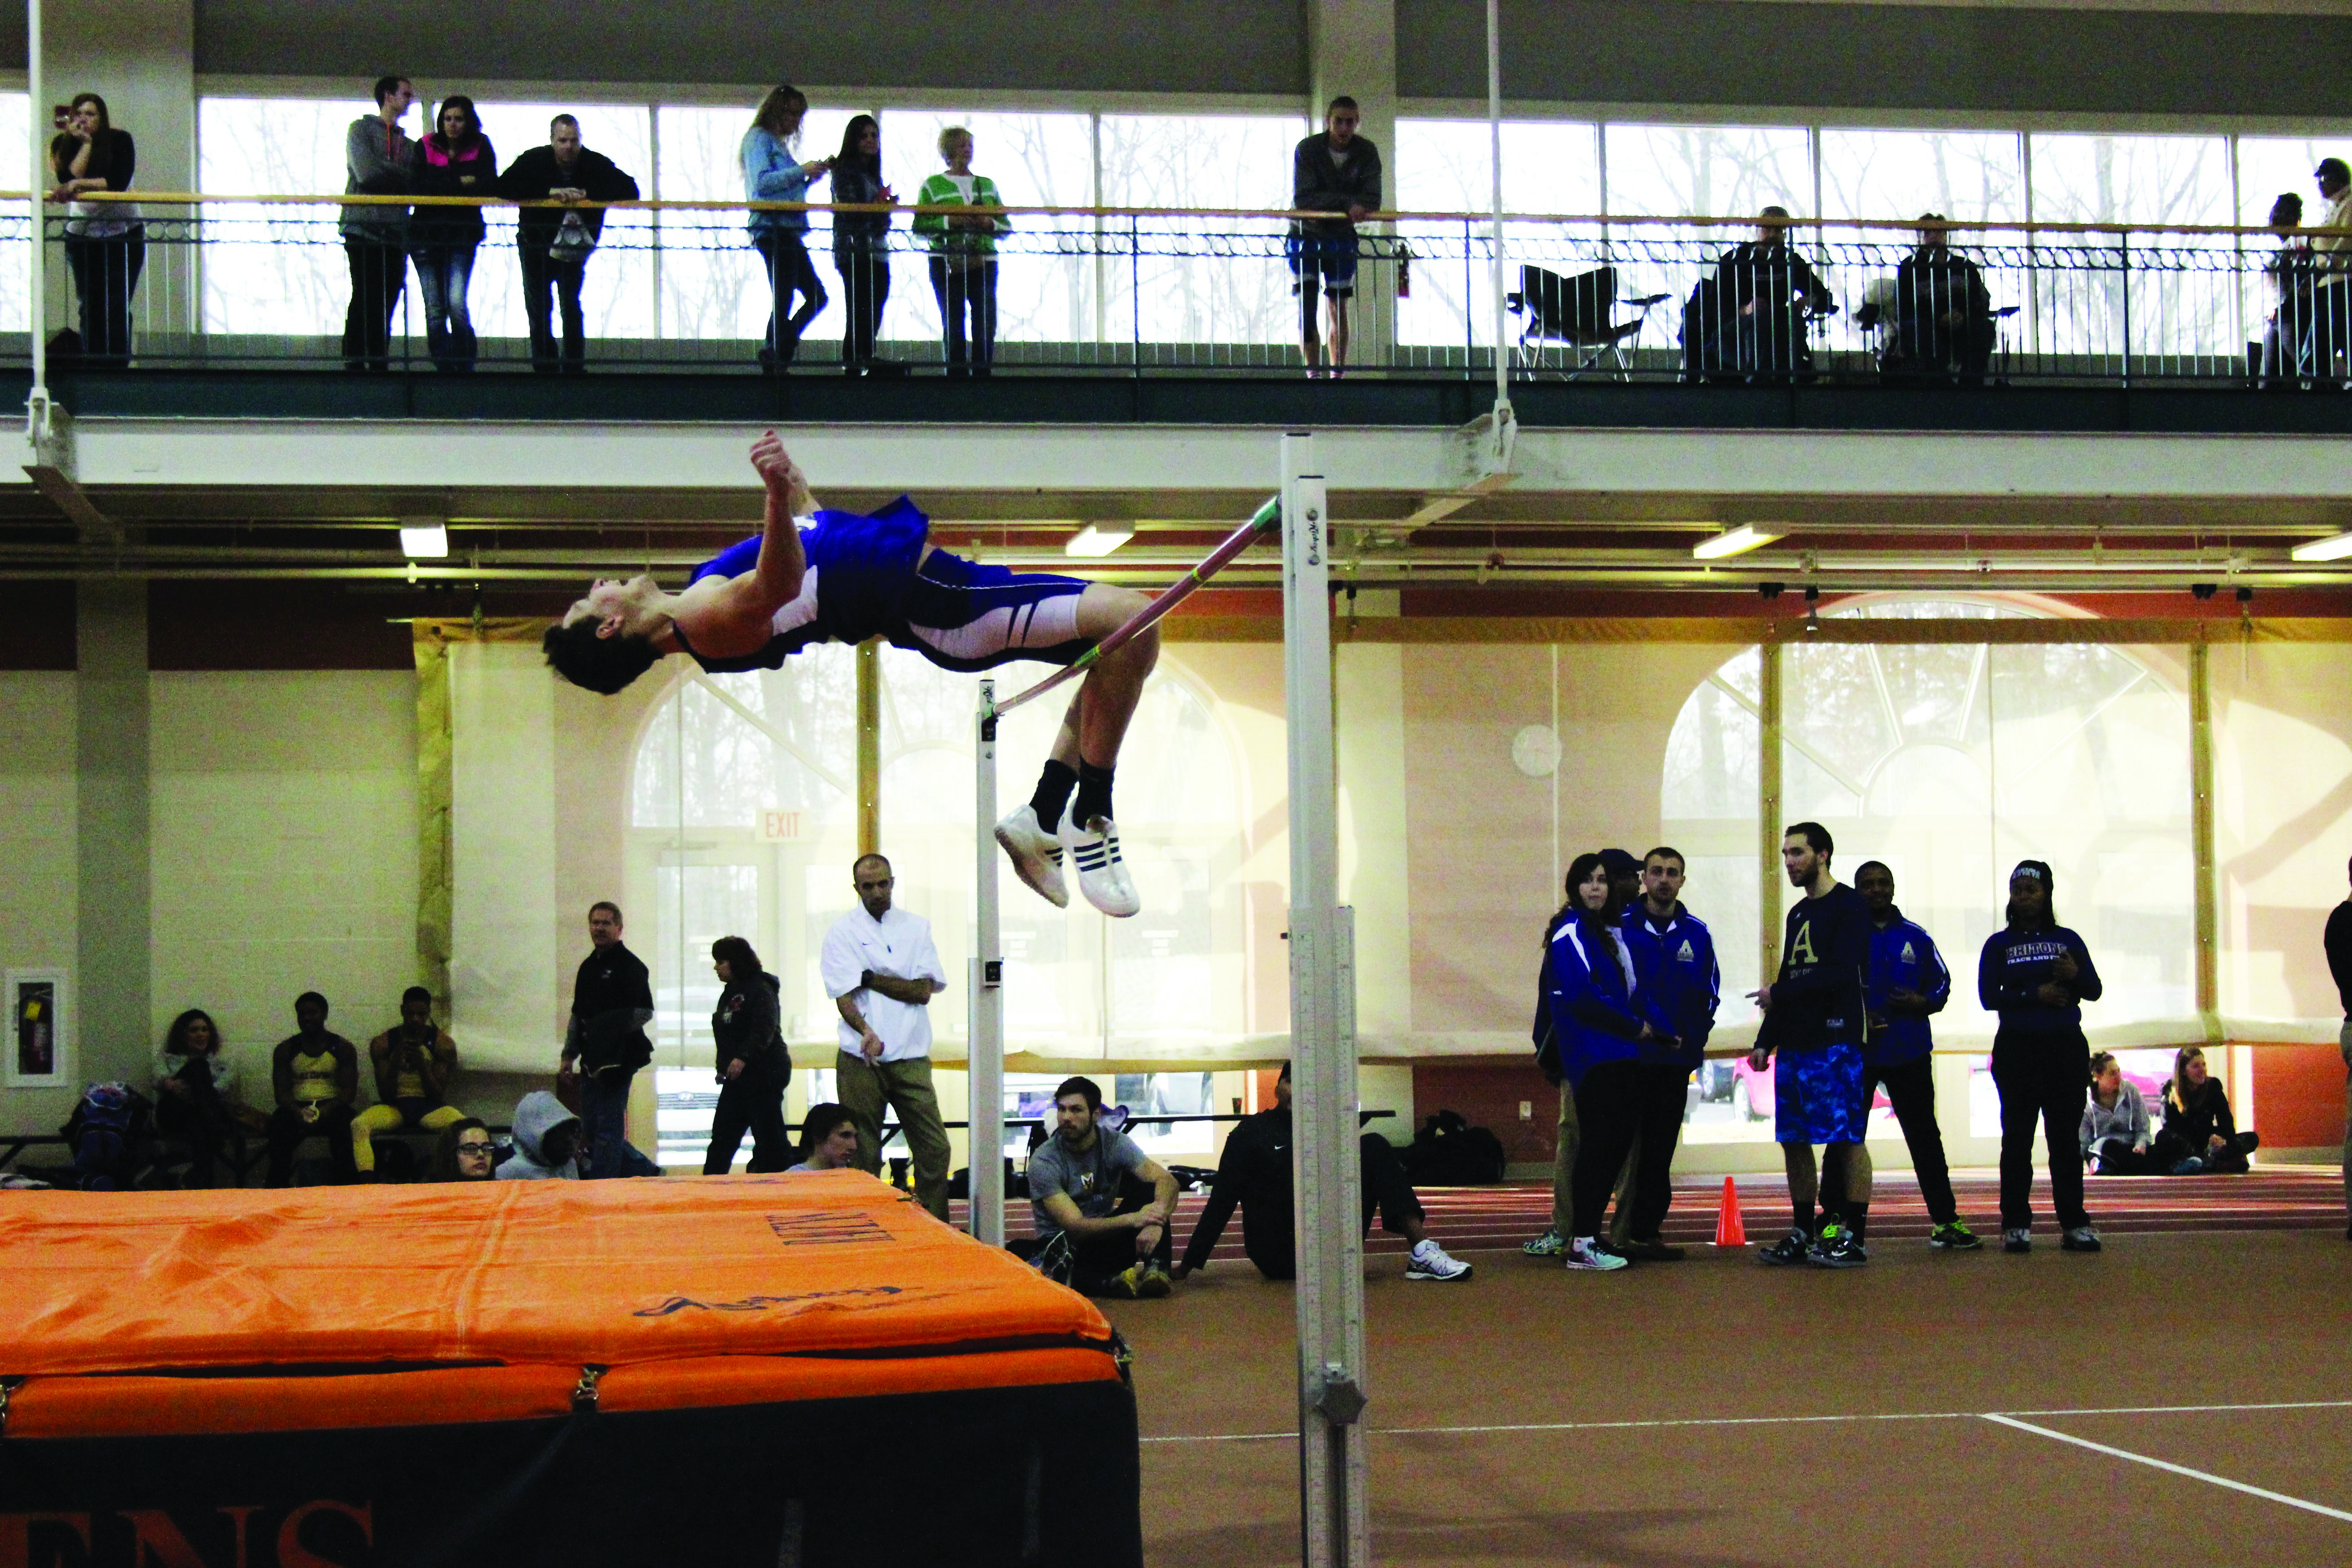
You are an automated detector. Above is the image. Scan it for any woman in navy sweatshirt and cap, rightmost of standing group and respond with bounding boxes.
[1976,860,2102,1253]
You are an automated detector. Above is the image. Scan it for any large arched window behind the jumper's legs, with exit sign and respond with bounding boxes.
[628,644,1244,1065]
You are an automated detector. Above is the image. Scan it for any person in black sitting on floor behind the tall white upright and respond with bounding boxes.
[1176,1063,1470,1281]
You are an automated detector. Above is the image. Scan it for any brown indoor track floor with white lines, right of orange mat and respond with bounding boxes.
[988,1168,2352,1568]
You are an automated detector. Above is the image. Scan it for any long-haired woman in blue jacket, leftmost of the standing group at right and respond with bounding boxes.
[1543,853,1689,1269]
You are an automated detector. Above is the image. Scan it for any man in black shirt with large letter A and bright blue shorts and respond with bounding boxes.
[1748,823,1872,1269]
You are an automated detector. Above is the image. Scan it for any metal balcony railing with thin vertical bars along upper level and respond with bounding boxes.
[14,193,2352,388]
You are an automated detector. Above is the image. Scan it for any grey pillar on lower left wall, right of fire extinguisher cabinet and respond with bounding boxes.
[73,578,155,1086]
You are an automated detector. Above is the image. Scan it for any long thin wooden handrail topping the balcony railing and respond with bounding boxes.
[18,191,2352,242]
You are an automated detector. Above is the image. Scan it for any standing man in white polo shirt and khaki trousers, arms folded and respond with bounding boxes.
[821,856,948,1220]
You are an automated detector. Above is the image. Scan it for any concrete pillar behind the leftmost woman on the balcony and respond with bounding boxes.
[33,0,202,341]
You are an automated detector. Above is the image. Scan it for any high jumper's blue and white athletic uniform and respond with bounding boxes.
[677,496,1094,672]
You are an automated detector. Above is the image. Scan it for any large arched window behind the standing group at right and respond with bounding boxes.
[1661,597,2197,1136]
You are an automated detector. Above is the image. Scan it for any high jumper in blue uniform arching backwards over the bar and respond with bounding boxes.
[544,430,1160,915]
